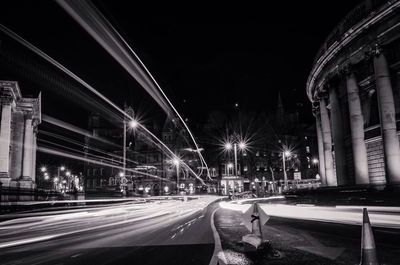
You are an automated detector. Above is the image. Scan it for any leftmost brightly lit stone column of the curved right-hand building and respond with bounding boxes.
[319,98,337,186]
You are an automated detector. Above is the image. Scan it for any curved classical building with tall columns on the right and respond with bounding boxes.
[306,0,400,186]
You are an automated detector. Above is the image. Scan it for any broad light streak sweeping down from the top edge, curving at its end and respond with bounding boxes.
[56,0,211,179]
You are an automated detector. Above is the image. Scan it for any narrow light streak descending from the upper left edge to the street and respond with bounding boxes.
[0,24,205,185]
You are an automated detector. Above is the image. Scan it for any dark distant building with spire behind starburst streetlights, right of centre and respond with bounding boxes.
[204,95,318,195]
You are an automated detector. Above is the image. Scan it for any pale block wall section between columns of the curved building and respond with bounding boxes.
[366,139,386,184]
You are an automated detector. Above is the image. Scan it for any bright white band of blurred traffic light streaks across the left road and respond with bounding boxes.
[0,196,218,251]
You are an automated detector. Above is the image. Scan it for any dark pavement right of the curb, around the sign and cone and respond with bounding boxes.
[215,203,400,265]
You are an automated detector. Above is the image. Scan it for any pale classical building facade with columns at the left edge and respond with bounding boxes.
[0,81,41,189]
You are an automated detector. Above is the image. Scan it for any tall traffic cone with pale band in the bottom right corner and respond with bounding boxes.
[360,208,379,265]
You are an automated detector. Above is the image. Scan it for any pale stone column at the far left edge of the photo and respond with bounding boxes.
[0,97,12,182]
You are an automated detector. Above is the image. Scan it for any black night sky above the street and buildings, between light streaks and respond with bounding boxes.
[0,0,358,128]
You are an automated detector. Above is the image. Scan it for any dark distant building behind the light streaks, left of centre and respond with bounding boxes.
[84,108,203,195]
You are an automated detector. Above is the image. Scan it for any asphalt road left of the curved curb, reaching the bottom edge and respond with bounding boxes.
[0,197,218,265]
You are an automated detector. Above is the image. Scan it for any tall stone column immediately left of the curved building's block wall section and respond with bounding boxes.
[346,73,369,184]
